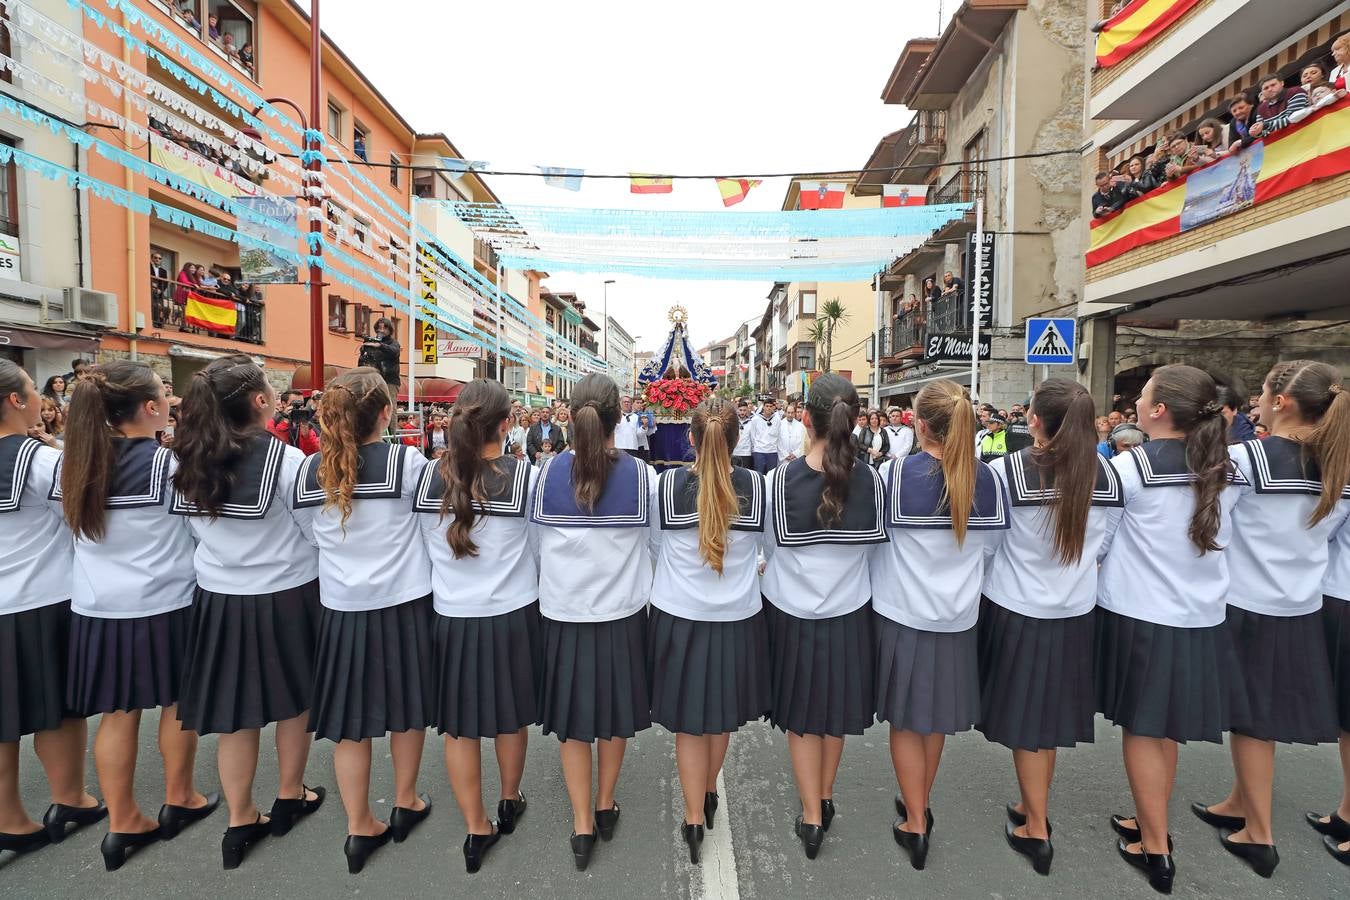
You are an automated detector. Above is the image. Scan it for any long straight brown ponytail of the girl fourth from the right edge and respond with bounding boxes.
[1030,378,1098,565]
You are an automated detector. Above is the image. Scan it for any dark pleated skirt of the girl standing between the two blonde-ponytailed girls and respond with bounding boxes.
[764,599,876,738]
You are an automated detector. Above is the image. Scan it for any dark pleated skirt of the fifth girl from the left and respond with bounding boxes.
[435,602,544,738]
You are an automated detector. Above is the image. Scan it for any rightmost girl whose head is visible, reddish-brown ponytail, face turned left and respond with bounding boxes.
[1191,360,1350,877]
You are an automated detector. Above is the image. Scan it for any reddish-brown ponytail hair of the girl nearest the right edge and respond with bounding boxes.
[1266,359,1350,528]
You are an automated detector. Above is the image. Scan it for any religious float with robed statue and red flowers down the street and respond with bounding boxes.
[637,306,717,470]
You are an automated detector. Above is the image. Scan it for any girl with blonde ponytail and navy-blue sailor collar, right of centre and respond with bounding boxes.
[872,381,1008,869]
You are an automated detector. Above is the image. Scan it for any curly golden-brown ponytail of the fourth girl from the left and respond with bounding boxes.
[319,366,393,525]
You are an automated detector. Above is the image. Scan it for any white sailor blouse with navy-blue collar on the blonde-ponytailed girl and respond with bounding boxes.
[872,452,1010,631]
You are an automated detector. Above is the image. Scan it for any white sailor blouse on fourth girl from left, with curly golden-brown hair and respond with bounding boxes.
[293,441,431,613]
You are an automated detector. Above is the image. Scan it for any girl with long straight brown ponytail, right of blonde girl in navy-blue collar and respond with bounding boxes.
[979,378,1125,874]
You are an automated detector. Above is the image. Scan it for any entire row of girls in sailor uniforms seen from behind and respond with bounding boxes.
[0,356,1350,891]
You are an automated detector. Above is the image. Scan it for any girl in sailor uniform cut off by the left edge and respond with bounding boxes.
[0,359,108,853]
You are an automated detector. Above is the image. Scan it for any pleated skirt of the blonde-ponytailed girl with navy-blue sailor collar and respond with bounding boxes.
[876,613,980,734]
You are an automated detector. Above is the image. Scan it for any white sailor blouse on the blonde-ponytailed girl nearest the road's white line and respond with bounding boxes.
[652,467,765,622]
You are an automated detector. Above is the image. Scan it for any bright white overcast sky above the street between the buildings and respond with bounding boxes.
[321,0,959,349]
